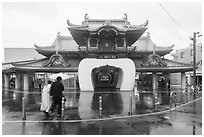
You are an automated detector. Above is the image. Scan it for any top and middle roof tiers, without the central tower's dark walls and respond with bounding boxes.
[34,14,173,57]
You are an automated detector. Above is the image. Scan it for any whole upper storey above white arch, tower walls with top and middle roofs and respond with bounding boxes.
[34,14,173,58]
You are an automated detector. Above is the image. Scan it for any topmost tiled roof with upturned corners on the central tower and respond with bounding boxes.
[67,14,148,46]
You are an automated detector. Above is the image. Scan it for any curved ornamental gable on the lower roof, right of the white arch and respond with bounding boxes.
[141,53,167,67]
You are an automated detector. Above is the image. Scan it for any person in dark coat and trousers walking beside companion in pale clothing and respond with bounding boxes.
[50,77,64,117]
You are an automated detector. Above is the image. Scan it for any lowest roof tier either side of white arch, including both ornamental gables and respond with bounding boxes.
[3,53,196,73]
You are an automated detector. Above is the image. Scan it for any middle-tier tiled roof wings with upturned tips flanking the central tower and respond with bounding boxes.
[35,36,174,56]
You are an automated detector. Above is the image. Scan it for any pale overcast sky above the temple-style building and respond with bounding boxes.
[2,2,202,53]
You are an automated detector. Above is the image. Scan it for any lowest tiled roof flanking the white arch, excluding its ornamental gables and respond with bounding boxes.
[5,58,195,72]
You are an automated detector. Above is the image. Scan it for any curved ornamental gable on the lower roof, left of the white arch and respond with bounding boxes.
[44,54,71,67]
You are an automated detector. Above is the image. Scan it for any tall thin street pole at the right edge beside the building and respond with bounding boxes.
[190,32,202,95]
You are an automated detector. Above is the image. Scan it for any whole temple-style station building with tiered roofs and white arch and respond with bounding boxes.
[2,14,196,91]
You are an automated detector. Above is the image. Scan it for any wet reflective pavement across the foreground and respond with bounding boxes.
[2,89,202,135]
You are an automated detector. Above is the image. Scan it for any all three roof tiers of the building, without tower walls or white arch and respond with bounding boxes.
[3,14,193,73]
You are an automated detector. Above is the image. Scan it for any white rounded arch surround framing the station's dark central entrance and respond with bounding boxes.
[78,58,136,91]
